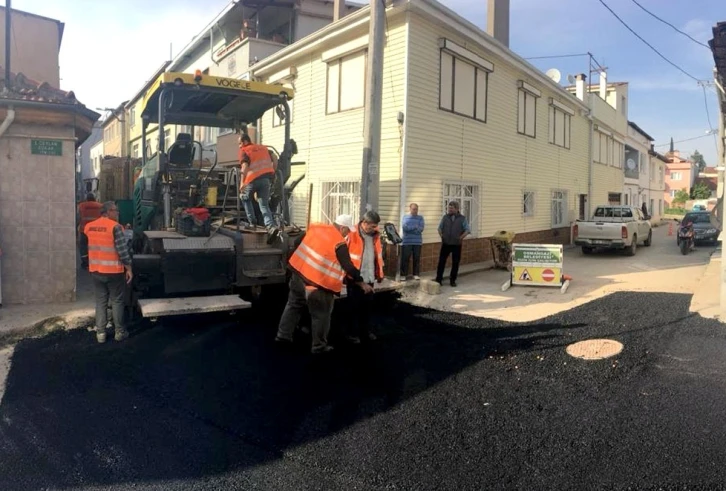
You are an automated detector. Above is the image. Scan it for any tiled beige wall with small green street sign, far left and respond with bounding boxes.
[0,124,76,304]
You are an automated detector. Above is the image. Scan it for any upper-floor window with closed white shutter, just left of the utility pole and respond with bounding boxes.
[325,50,366,114]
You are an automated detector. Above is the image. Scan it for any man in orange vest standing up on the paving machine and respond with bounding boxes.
[239,133,277,233]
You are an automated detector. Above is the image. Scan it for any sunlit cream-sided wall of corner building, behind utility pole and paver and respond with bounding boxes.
[255,13,407,224]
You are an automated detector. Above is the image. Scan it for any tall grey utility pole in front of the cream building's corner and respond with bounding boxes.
[360,0,386,218]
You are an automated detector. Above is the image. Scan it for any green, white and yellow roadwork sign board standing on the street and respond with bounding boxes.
[512,244,564,287]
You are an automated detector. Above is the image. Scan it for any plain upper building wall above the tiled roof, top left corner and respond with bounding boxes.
[0,7,63,87]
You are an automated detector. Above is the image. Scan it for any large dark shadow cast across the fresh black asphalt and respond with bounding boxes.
[0,295,716,488]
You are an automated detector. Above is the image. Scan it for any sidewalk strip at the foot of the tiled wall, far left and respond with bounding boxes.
[0,269,95,347]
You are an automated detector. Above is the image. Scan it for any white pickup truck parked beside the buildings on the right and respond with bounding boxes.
[572,205,653,256]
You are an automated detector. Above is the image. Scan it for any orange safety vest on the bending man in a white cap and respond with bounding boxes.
[289,223,345,294]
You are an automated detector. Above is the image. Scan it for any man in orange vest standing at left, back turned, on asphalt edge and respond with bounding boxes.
[82,201,133,343]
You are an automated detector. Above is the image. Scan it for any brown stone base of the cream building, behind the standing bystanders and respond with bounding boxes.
[385,227,571,276]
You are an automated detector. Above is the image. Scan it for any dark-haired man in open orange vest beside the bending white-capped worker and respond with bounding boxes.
[345,211,385,344]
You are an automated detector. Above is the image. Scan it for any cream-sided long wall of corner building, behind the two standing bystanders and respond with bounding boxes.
[405,14,589,246]
